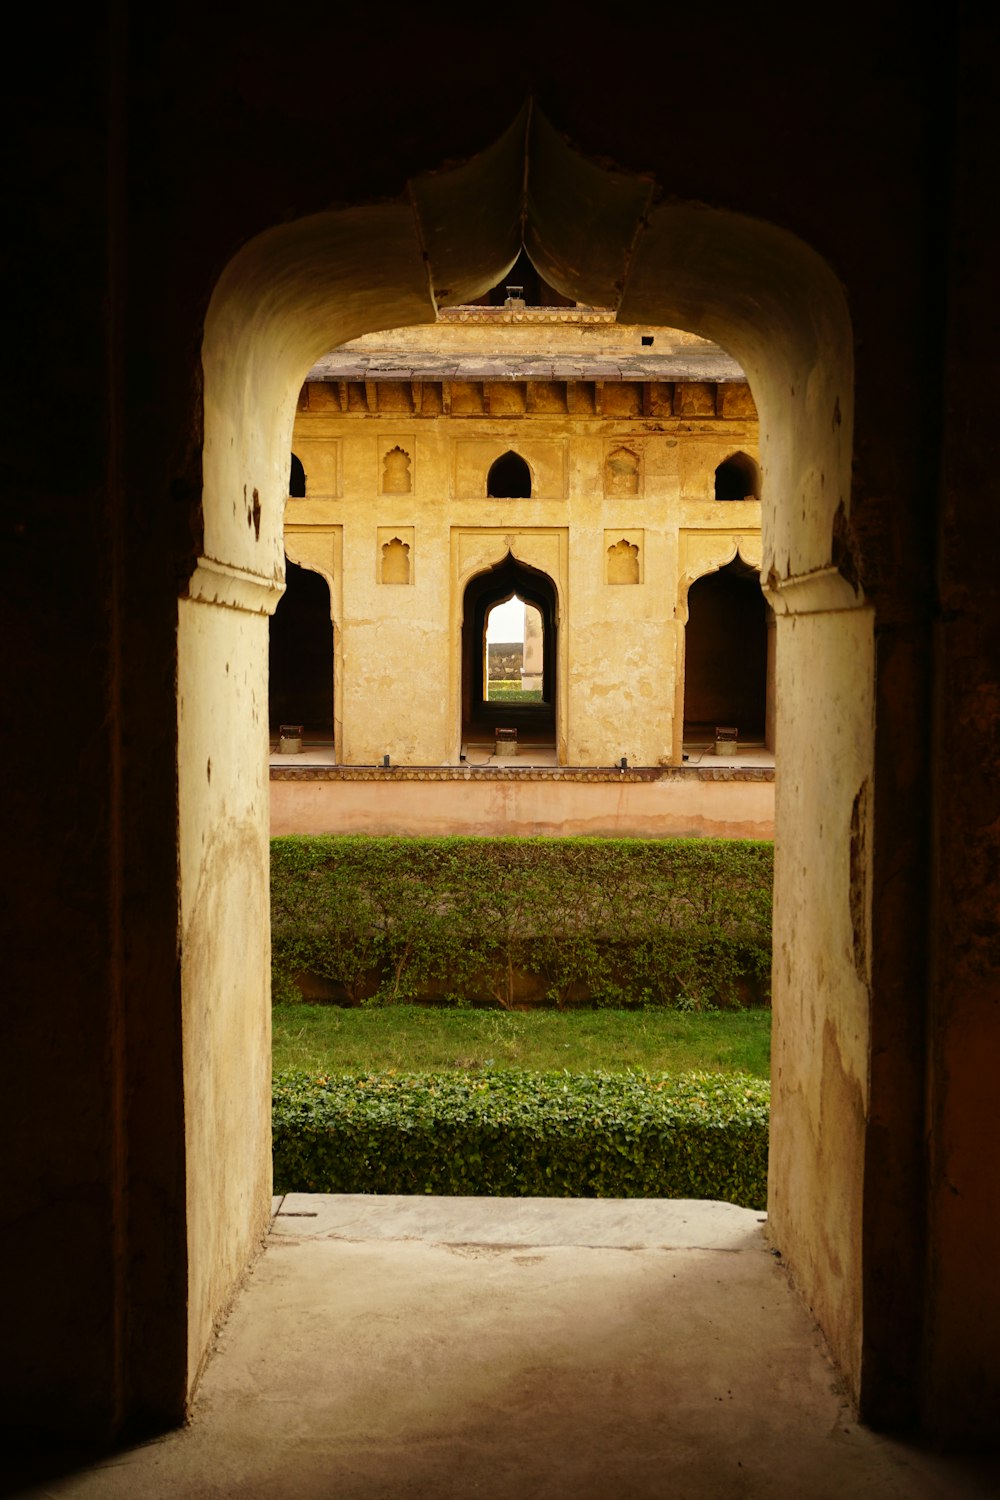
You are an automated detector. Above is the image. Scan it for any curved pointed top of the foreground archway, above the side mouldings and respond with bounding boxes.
[200,110,859,603]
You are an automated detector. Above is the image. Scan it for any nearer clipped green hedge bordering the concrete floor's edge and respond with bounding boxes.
[274,1071,769,1209]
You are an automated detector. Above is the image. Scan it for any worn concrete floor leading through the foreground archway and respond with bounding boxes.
[18,1196,999,1500]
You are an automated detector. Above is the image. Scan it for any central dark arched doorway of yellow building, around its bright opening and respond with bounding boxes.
[462,554,558,750]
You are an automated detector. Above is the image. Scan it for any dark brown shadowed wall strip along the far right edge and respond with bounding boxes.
[922,12,1000,1442]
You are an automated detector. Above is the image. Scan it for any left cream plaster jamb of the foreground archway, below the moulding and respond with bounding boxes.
[177,599,271,1383]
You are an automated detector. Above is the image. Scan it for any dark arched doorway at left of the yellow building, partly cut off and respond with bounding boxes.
[268,558,333,738]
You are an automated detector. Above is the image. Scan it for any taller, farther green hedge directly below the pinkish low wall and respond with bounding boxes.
[271,837,772,1010]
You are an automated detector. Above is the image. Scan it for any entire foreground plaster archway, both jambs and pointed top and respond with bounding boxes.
[189,108,875,1416]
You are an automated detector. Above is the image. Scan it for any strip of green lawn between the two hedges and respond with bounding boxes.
[273,1005,771,1079]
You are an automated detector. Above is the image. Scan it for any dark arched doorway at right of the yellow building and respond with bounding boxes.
[684,569,768,740]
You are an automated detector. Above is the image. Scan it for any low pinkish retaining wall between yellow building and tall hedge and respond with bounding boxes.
[271,765,774,839]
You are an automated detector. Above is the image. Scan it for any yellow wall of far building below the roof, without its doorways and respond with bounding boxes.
[285,381,760,765]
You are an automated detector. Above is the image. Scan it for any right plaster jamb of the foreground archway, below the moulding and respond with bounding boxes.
[769,584,874,1380]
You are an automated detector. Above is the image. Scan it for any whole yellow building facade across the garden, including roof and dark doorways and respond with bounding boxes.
[271,306,774,767]
